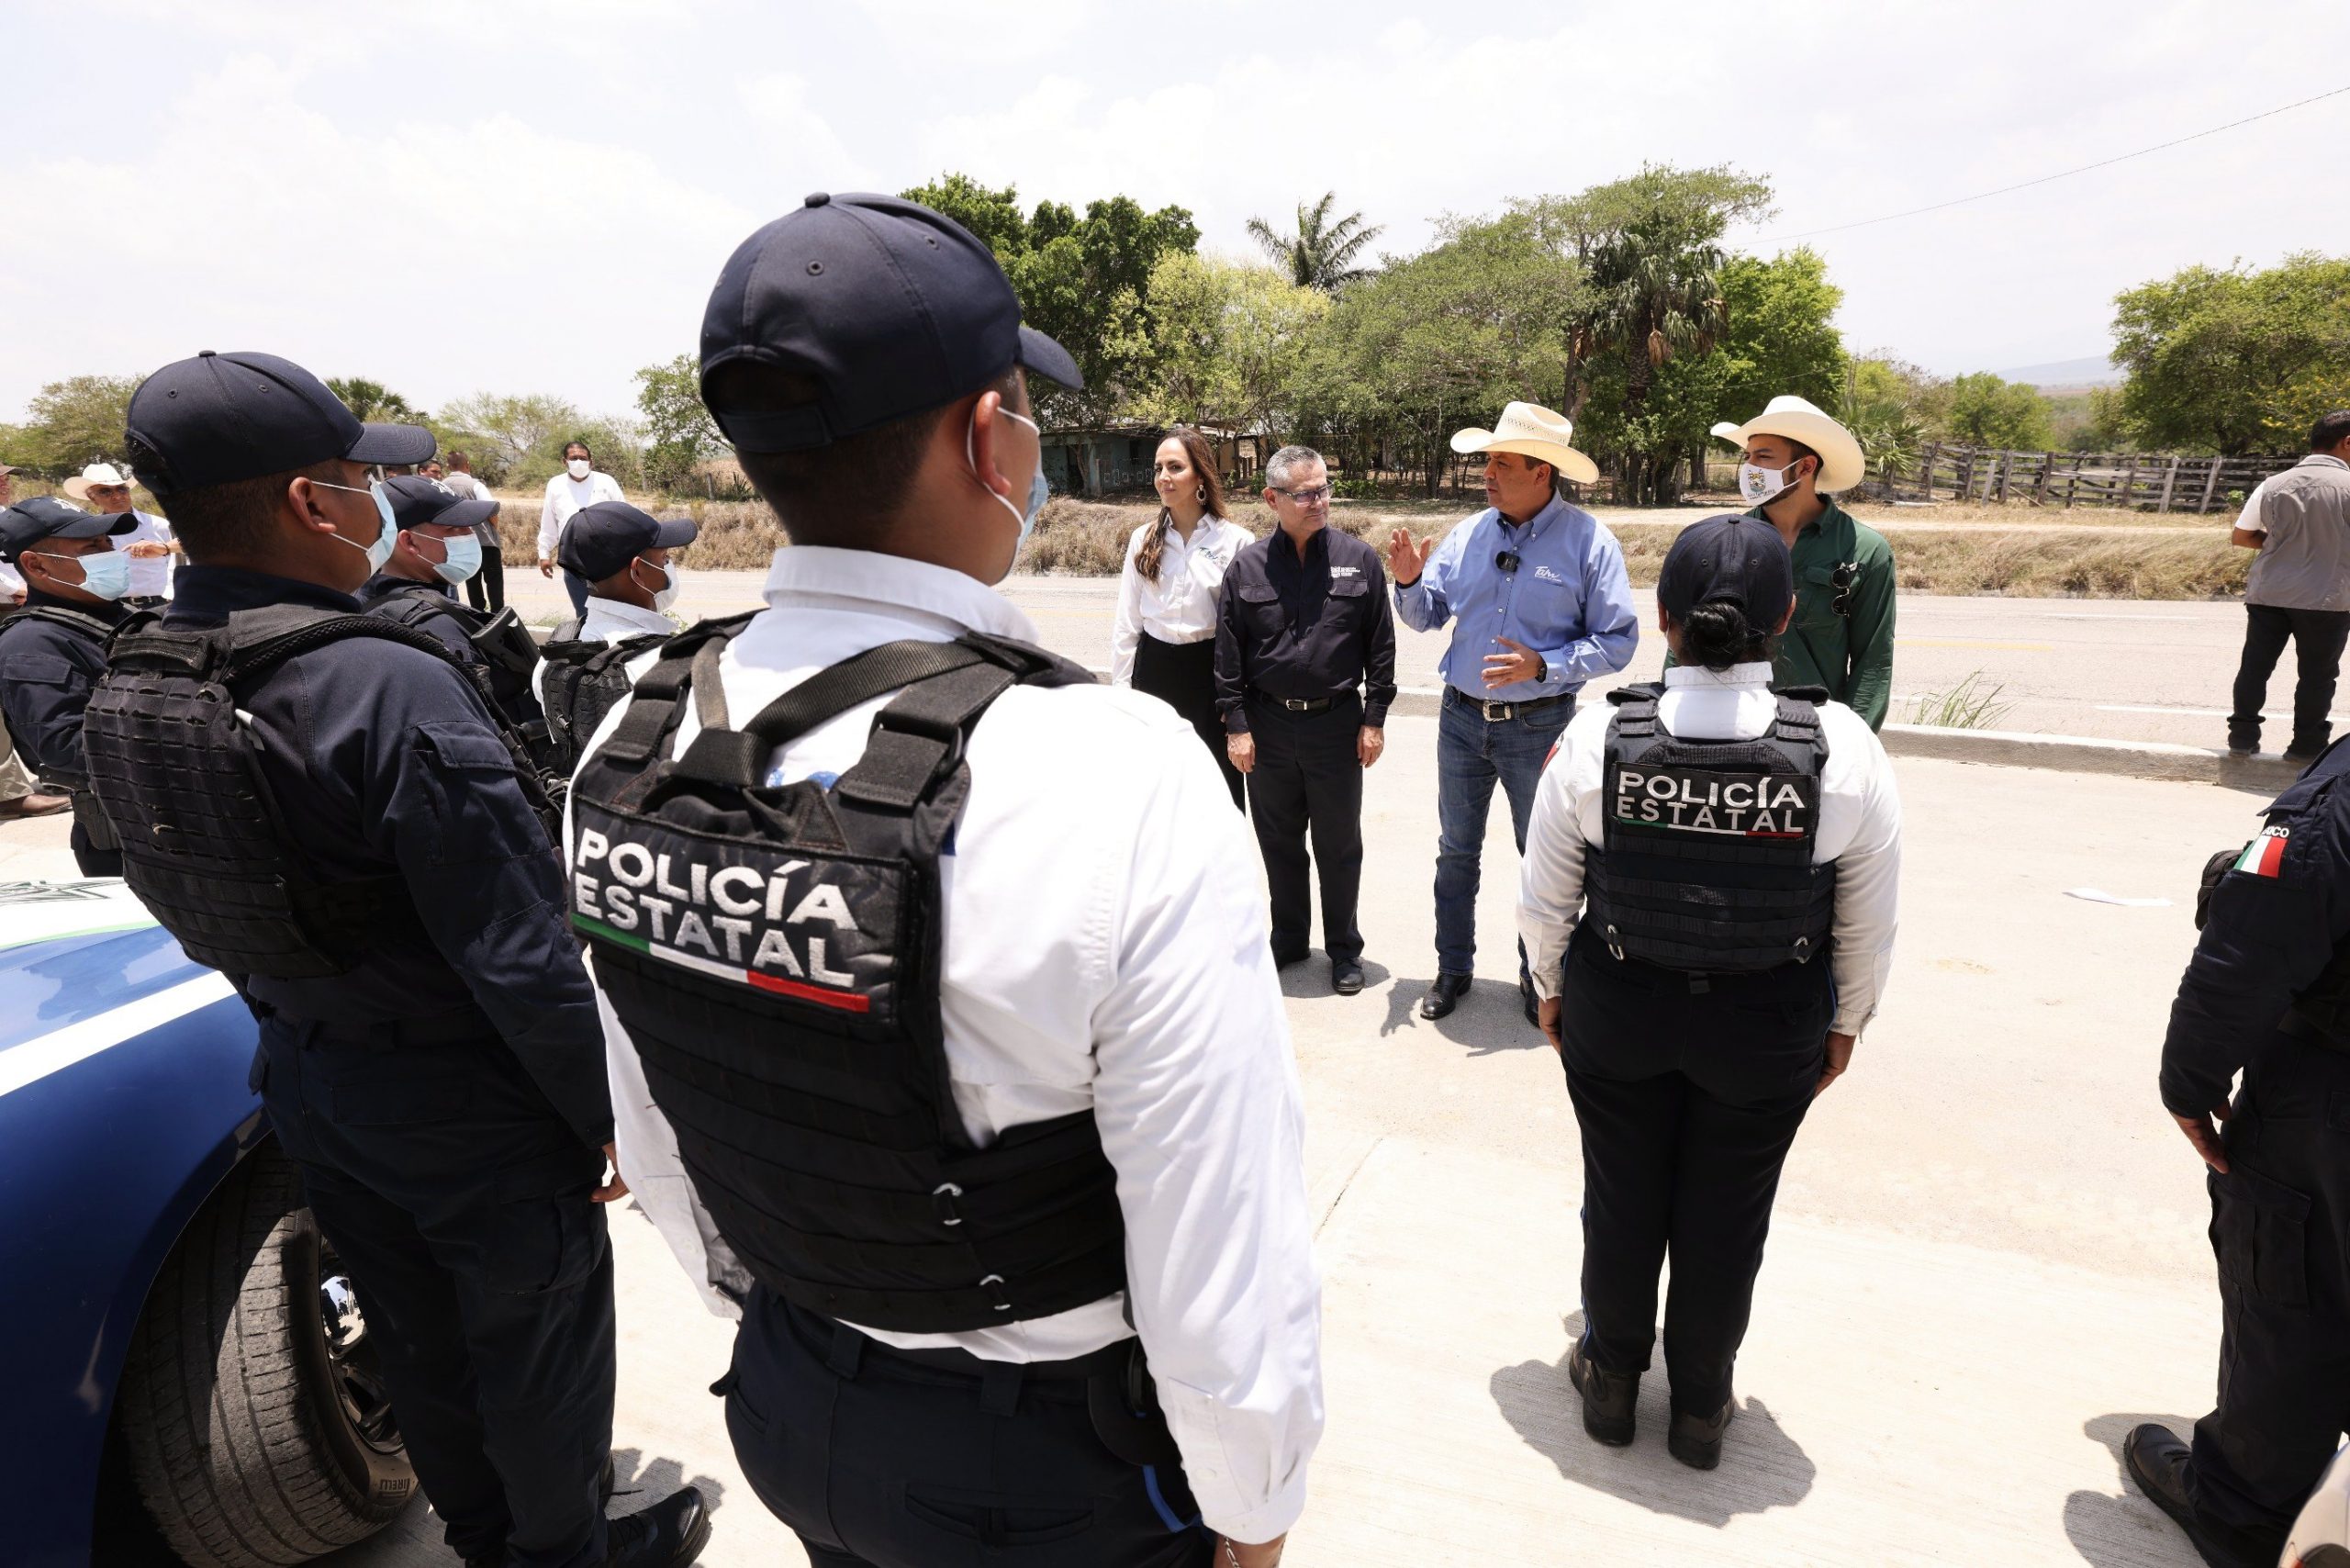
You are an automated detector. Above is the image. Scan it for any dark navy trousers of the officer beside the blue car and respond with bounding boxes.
[256,1018,613,1568]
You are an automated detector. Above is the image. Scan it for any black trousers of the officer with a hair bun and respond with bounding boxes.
[1561,931,1833,1416]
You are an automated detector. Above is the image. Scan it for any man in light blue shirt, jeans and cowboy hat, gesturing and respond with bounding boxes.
[1386,402,1640,1023]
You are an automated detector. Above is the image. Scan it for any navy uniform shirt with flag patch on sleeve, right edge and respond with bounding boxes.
[2162,745,2350,1116]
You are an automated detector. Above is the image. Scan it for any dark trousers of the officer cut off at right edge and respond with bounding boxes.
[2188,1032,2350,1568]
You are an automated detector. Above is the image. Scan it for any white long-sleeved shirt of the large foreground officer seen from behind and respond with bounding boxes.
[576,545,1323,1540]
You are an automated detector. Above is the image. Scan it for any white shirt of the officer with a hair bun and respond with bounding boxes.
[1518,663,1901,1035]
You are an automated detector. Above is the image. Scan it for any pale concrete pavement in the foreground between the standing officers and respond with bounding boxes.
[0,728,2256,1568]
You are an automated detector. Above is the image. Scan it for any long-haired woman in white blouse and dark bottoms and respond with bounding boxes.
[1109,425,1250,806]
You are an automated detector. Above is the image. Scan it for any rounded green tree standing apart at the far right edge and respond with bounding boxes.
[2112,252,2350,456]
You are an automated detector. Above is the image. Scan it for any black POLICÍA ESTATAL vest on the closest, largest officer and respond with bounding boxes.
[569,621,1125,1333]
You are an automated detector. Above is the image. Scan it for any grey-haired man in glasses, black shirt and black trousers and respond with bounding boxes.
[1215,447,1396,997]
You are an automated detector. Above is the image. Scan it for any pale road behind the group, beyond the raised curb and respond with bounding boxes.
[508,571,2293,750]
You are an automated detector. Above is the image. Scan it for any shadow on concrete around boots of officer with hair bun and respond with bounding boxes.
[1487,1316,1818,1530]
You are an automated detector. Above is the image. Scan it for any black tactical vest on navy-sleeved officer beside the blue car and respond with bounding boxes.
[83,604,562,980]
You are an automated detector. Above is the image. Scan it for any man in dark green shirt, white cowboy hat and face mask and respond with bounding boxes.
[1713,398,1894,729]
